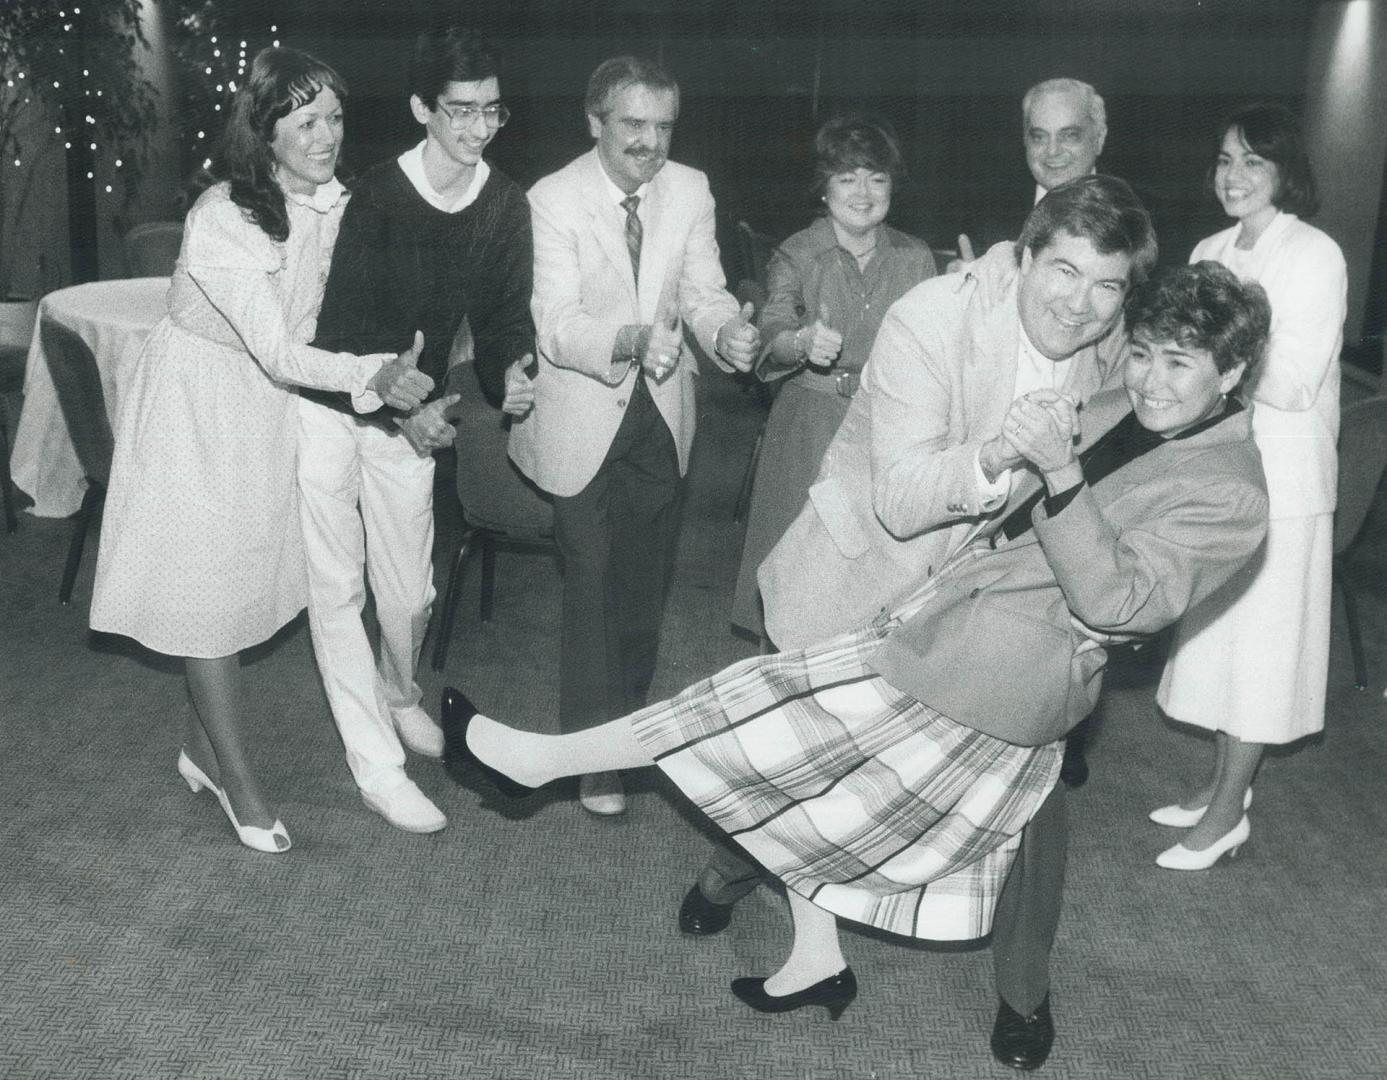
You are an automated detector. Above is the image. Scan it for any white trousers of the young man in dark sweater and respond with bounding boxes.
[298,399,434,790]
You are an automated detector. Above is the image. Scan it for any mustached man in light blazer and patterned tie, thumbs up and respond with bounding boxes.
[510,57,759,814]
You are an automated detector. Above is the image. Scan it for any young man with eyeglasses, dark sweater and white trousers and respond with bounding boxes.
[306,29,534,832]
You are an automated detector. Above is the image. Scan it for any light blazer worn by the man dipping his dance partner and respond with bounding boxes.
[759,267,1126,649]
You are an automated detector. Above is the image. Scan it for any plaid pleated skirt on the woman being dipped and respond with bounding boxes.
[631,627,1062,940]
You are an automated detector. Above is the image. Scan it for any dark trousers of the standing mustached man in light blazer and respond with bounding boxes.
[553,376,680,732]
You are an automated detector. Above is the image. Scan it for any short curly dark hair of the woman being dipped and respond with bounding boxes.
[1125,261,1272,377]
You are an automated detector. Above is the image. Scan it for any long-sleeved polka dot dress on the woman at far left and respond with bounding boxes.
[92,182,381,657]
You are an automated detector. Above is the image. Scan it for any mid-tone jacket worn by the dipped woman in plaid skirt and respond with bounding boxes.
[868,390,1268,746]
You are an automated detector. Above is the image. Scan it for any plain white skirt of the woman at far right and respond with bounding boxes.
[1155,514,1334,744]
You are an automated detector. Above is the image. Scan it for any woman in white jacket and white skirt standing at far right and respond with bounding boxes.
[1151,105,1348,869]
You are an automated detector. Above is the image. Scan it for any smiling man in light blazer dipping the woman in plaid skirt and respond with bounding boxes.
[680,176,1157,1069]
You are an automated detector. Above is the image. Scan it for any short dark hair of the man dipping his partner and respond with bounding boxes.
[1017,173,1158,286]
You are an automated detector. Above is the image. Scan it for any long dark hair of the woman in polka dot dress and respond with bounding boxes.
[211,49,347,243]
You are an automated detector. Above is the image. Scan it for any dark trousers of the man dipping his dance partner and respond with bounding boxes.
[699,783,1069,1016]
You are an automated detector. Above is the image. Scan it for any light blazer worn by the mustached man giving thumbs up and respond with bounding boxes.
[510,148,738,495]
